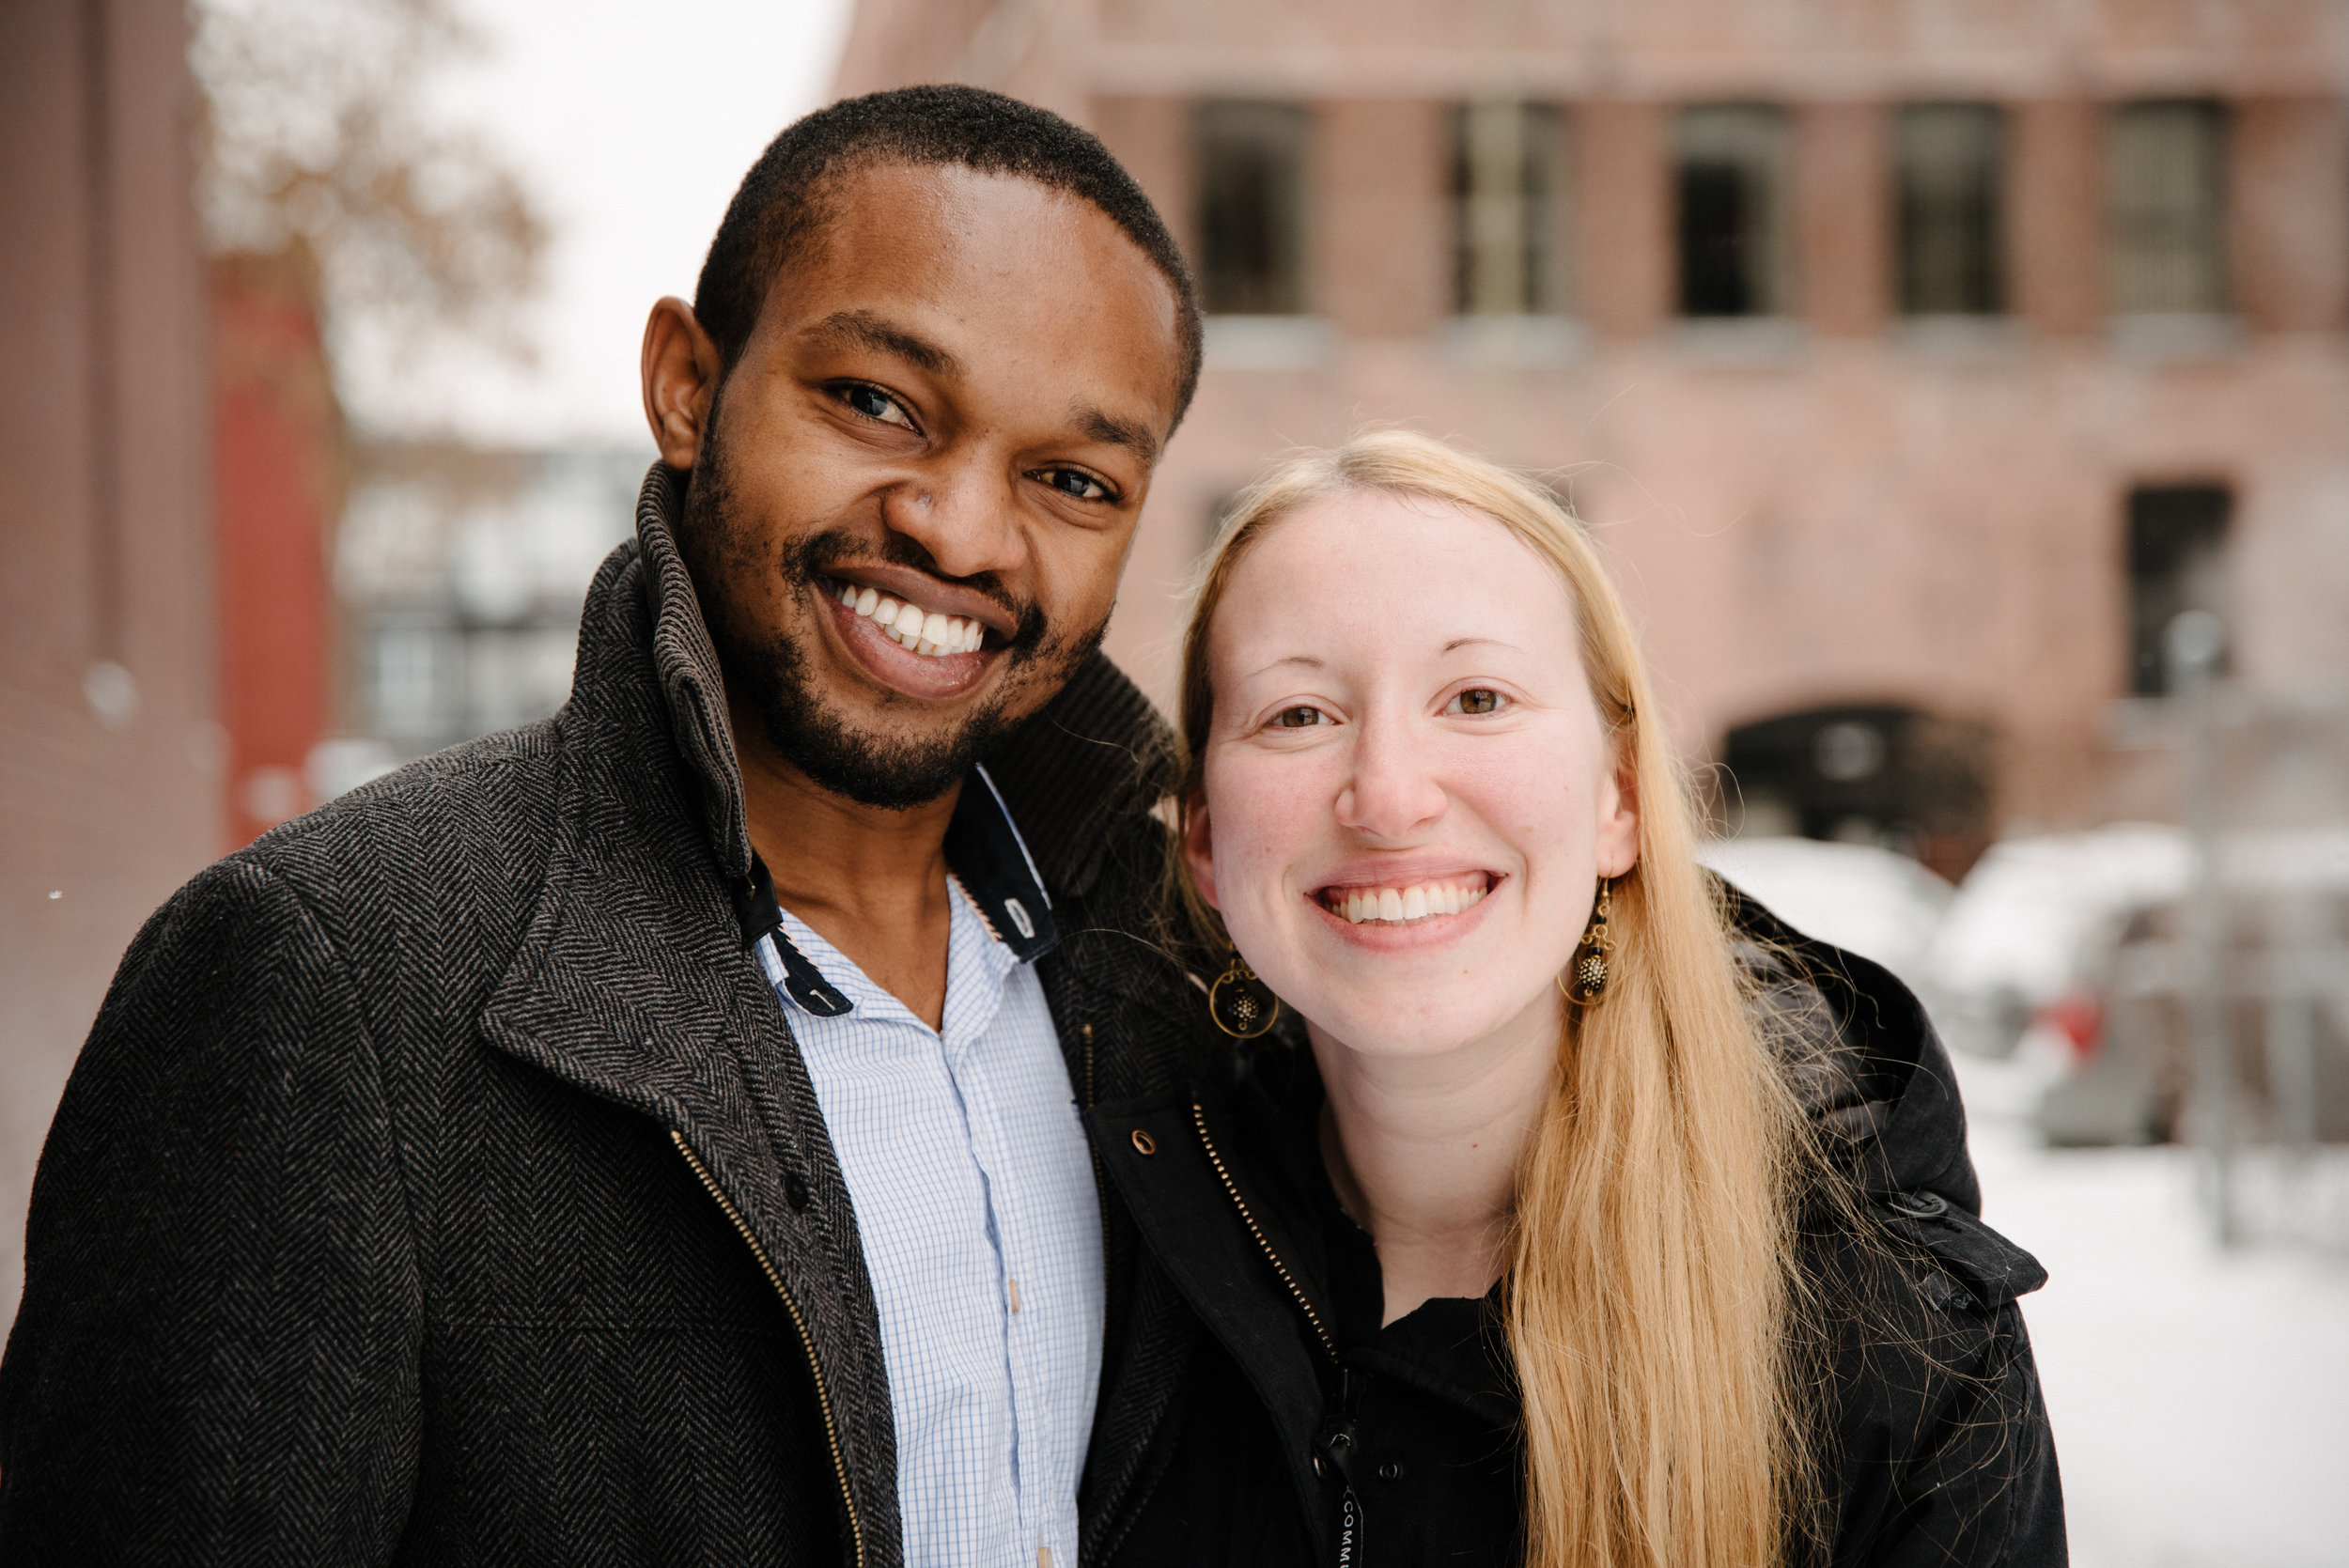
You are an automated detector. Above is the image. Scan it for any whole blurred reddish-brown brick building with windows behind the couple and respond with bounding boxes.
[836,0,2349,871]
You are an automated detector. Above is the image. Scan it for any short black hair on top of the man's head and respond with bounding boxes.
[693,85,1201,425]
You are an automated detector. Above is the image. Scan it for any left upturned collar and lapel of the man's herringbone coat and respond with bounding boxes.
[479,465,900,1568]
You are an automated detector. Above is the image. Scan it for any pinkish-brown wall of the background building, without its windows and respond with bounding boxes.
[839,0,2349,826]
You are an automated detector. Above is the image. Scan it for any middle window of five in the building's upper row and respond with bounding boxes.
[1677,103,1793,317]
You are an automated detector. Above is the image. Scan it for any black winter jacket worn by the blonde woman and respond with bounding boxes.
[1088,899,2065,1568]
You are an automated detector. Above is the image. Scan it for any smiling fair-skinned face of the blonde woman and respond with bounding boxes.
[1184,490,1638,1056]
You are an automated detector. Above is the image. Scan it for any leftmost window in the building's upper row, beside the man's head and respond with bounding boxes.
[1198,103,1311,315]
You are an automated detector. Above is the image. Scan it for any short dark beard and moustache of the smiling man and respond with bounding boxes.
[677,411,1109,810]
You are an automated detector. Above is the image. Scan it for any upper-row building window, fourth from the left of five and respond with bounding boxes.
[1896,103,2006,317]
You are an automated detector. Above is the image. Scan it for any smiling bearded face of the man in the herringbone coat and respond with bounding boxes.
[679,166,1179,807]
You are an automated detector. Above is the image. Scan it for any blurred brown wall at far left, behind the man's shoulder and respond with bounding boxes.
[0,0,224,1319]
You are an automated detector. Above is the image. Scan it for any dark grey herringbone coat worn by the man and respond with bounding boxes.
[0,465,1206,1568]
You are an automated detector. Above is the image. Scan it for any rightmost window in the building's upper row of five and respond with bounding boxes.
[2108,103,2227,315]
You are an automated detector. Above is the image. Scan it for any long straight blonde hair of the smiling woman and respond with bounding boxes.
[1177,429,1812,1568]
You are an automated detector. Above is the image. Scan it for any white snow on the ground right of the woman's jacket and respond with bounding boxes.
[1959,1059,2349,1568]
